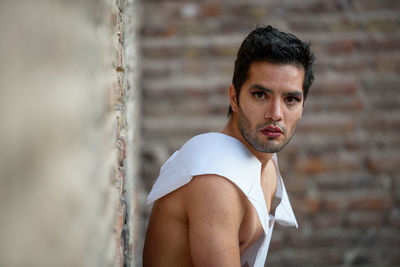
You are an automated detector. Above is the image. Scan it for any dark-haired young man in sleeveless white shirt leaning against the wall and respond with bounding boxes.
[143,26,314,267]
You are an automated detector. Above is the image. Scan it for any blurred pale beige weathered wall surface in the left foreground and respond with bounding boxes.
[0,0,140,267]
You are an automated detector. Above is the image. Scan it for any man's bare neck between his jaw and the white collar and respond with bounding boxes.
[220,114,273,170]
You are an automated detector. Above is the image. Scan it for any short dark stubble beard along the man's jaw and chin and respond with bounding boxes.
[237,106,294,153]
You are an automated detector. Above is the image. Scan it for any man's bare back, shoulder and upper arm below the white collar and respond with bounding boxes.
[144,175,246,266]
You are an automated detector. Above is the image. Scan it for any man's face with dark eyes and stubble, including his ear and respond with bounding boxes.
[230,62,304,153]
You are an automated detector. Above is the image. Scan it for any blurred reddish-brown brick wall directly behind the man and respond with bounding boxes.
[141,0,400,266]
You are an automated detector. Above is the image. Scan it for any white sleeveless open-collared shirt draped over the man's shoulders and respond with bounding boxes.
[147,133,298,267]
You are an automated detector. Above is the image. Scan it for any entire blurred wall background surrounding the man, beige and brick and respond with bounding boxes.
[0,0,400,267]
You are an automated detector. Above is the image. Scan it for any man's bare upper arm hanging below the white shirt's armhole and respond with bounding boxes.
[185,175,245,267]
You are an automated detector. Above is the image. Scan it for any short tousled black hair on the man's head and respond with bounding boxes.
[228,26,315,116]
